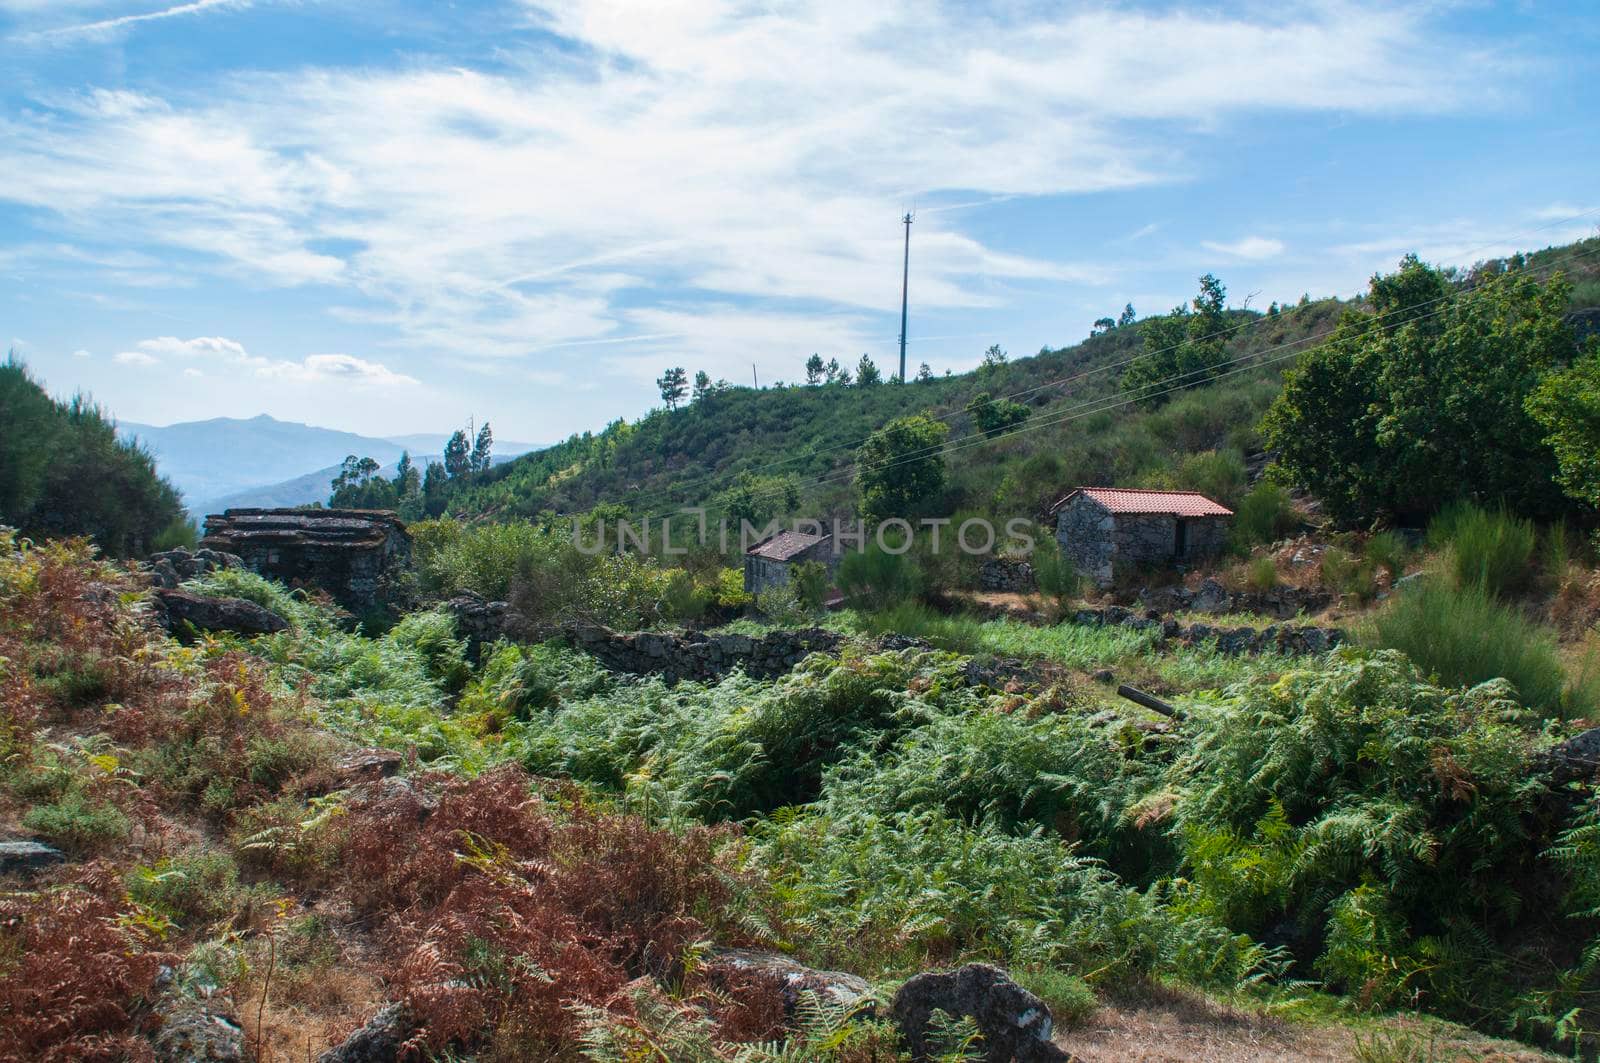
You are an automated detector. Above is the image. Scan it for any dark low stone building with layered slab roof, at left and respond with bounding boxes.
[200,509,411,613]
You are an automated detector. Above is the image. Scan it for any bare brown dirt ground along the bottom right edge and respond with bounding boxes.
[1056,988,1562,1063]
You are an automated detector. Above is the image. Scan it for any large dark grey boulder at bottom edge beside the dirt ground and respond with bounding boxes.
[890,964,1072,1063]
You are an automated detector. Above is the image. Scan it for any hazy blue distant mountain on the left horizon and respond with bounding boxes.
[117,413,533,517]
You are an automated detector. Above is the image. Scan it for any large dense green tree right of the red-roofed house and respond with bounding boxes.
[1262,255,1573,523]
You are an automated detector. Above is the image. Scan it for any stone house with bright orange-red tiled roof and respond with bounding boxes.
[1051,487,1234,586]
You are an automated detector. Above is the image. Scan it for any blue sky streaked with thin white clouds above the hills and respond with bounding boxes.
[0,0,1600,440]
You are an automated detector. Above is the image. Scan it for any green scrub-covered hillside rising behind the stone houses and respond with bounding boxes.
[450,240,1600,519]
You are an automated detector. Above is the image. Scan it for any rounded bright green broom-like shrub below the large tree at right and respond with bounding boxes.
[1374,578,1565,714]
